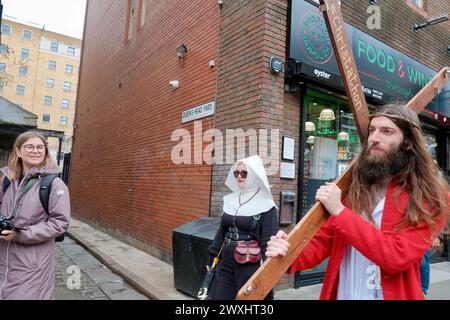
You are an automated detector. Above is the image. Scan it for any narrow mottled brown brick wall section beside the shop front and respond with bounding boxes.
[211,0,287,215]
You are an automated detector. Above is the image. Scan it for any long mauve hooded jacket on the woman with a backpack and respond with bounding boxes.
[0,168,70,300]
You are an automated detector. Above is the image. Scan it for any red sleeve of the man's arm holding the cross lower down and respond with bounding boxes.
[287,216,335,274]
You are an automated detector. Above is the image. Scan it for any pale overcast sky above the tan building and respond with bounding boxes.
[2,0,86,39]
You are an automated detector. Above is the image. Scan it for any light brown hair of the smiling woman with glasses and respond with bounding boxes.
[8,131,56,181]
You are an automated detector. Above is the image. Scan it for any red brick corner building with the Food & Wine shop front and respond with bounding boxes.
[70,0,450,292]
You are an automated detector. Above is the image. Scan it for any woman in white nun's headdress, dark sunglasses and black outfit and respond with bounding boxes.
[207,155,278,300]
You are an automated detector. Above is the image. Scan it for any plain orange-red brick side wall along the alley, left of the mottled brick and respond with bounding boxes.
[70,0,219,261]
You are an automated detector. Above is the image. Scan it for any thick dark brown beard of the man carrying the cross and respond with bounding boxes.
[357,142,408,186]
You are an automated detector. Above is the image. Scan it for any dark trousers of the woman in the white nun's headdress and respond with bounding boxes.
[212,245,273,300]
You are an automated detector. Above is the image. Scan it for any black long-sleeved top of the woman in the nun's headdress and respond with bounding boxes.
[208,207,279,265]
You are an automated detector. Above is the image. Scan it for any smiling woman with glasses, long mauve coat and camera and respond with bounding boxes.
[0,131,70,300]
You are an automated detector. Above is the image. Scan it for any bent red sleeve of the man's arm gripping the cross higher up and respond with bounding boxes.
[334,208,431,273]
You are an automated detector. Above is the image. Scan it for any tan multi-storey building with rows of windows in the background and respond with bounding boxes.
[0,16,81,165]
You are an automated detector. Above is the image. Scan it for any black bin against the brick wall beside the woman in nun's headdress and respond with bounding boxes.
[172,217,220,297]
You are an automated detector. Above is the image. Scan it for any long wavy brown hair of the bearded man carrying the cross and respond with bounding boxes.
[347,105,449,232]
